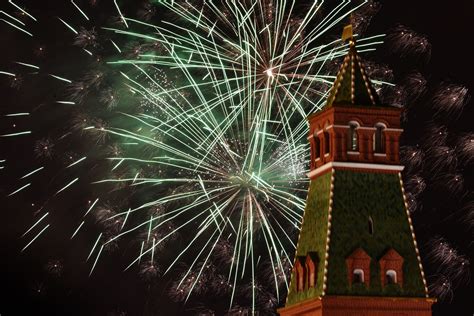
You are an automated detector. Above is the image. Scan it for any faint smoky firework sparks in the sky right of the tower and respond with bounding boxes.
[388,22,472,302]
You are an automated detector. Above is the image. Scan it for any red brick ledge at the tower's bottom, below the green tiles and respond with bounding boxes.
[278,296,435,316]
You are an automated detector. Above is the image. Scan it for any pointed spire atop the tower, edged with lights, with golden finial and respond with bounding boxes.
[325,25,381,107]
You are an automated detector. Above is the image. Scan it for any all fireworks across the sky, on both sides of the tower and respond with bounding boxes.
[0,0,473,315]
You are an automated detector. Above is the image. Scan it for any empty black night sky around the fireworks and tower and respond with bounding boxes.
[0,0,474,316]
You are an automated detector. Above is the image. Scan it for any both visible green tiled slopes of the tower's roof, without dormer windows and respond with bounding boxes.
[286,170,426,306]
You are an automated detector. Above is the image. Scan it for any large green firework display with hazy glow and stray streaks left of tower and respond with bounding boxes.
[3,0,388,314]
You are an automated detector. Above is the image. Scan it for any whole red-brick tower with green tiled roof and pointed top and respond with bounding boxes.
[279,26,434,316]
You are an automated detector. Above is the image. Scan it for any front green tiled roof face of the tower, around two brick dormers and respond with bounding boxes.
[326,170,426,297]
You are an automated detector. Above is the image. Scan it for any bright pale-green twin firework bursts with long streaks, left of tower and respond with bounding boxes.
[97,1,386,310]
